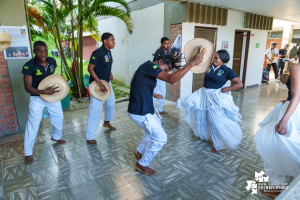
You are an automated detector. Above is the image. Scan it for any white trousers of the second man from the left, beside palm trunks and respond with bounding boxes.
[86,83,116,140]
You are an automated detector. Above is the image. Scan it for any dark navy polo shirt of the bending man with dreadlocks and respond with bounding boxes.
[128,60,162,115]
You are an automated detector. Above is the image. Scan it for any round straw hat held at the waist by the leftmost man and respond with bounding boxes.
[38,74,70,103]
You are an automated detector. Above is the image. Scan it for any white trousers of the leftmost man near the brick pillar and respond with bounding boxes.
[24,96,64,156]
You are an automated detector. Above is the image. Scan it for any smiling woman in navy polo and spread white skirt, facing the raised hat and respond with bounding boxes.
[177,50,243,153]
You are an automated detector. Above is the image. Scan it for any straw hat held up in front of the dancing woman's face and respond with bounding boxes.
[184,38,215,74]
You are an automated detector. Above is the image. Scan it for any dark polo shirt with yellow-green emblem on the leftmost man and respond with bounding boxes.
[22,57,57,96]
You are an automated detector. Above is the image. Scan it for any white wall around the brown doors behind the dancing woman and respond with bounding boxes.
[180,10,268,97]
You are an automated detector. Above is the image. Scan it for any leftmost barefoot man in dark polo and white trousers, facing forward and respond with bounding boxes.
[22,41,66,163]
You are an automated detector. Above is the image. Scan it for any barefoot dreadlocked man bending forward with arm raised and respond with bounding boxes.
[128,48,203,175]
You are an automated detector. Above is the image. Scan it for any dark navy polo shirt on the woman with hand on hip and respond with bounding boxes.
[204,65,238,89]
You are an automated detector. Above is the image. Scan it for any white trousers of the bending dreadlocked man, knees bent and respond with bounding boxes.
[128,113,167,167]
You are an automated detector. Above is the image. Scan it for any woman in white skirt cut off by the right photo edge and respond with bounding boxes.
[254,64,300,197]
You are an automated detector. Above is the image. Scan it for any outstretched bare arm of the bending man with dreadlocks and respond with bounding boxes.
[156,53,204,84]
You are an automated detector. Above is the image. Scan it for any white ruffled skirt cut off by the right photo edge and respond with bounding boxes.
[254,101,300,183]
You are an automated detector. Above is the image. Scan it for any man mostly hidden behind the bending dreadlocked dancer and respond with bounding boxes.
[153,37,170,114]
